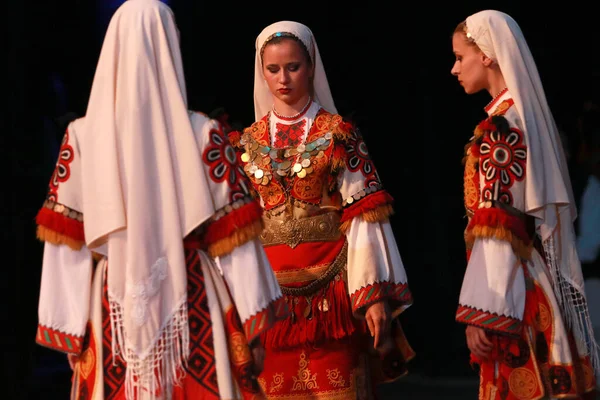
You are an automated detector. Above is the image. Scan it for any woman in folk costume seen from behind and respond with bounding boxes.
[37,0,289,400]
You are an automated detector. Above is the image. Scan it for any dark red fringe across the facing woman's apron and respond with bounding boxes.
[261,275,366,350]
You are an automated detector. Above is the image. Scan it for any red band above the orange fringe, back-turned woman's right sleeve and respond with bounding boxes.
[204,201,263,245]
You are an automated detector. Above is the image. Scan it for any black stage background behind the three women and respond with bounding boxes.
[5,0,600,399]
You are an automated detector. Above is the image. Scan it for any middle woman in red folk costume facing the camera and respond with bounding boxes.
[230,21,413,399]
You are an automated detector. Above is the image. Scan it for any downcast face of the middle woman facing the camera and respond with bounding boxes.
[262,38,313,105]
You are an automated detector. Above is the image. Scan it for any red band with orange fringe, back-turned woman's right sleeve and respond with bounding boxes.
[203,197,264,257]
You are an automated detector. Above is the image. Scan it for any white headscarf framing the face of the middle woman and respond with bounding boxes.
[254,21,337,121]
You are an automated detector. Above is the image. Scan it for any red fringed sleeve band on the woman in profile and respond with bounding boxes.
[465,207,531,259]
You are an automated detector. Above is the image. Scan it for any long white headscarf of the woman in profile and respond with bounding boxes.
[466,10,600,368]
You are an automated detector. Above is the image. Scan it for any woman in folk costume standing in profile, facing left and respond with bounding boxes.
[451,10,598,400]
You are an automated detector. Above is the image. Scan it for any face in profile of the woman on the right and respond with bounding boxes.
[450,32,489,94]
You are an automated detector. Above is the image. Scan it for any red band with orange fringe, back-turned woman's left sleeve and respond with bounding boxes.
[35,200,85,250]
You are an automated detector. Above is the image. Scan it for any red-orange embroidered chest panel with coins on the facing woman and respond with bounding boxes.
[240,110,342,210]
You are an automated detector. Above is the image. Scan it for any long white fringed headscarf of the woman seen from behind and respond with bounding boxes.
[80,0,214,398]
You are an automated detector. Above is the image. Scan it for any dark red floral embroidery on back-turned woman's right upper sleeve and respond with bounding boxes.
[202,125,249,202]
